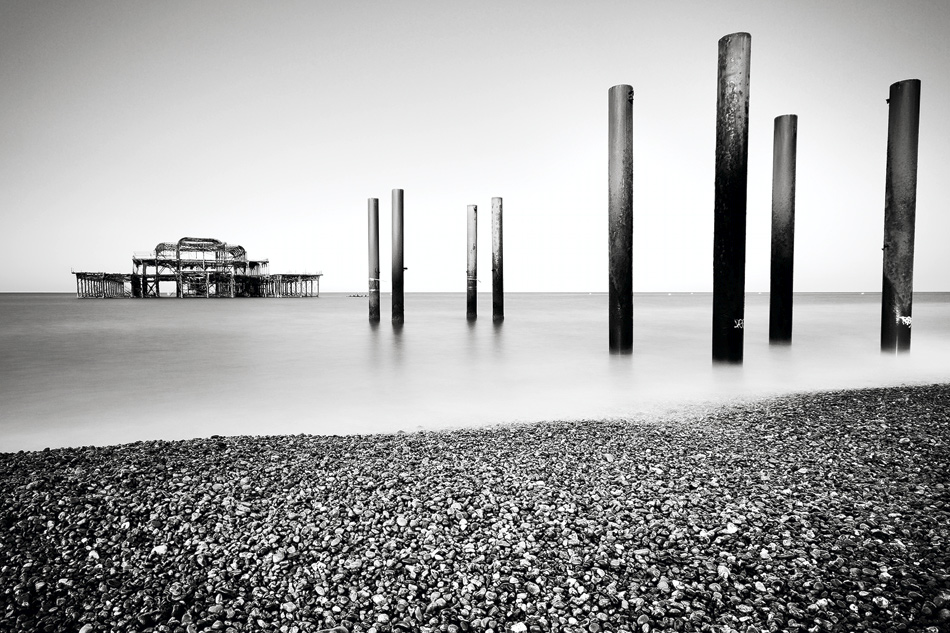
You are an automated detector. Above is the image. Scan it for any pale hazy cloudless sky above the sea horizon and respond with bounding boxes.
[0,0,950,292]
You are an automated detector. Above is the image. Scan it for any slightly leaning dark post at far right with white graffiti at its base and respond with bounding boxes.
[881,79,920,352]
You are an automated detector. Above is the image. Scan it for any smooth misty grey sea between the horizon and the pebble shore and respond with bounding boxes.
[0,293,950,451]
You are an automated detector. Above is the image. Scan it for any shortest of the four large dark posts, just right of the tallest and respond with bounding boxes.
[769,114,798,344]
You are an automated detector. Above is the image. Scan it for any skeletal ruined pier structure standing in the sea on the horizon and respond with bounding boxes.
[73,237,322,299]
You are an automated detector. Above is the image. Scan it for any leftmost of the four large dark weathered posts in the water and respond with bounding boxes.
[607,85,633,354]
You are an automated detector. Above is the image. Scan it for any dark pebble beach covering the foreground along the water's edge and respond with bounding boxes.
[0,385,950,633]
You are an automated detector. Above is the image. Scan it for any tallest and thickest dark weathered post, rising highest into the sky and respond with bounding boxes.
[712,33,752,363]
